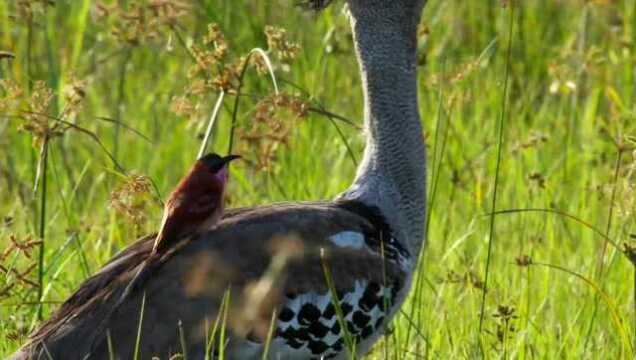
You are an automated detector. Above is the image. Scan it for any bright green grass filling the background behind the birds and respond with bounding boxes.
[0,0,636,359]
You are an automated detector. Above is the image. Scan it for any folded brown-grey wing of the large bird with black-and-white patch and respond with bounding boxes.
[22,204,408,358]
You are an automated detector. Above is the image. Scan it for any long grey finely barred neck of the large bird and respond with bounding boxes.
[342,0,426,255]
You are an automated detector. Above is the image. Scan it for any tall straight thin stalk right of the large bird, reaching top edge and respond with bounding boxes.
[478,2,515,335]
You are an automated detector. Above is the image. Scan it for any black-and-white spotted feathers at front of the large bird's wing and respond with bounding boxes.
[247,201,411,359]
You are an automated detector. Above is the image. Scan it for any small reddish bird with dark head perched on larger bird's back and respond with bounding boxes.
[152,153,240,254]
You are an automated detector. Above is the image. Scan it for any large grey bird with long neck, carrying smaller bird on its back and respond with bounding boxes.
[13,0,426,359]
